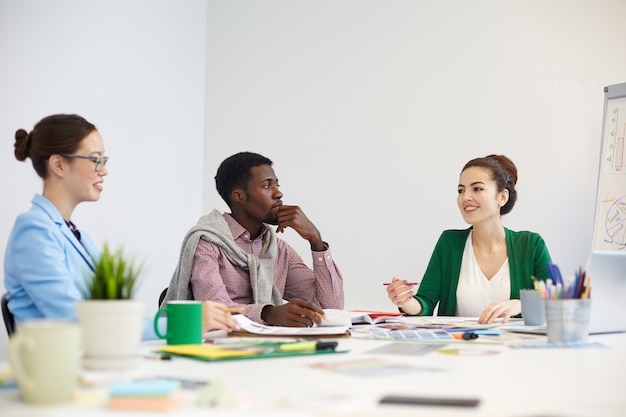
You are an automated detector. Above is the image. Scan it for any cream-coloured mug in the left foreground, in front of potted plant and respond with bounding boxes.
[8,319,80,404]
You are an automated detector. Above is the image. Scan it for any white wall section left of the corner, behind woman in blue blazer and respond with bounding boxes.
[0,0,206,360]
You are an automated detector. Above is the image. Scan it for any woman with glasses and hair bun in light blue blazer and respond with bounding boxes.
[4,114,236,338]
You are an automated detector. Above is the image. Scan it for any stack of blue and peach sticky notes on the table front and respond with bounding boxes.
[109,379,185,411]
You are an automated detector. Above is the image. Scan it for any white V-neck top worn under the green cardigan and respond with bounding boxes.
[456,231,511,317]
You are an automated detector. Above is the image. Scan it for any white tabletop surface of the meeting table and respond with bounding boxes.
[0,318,626,417]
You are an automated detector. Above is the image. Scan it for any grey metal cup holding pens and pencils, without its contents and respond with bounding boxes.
[545,299,591,343]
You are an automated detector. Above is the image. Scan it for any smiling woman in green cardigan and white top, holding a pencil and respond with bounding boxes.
[387,155,551,323]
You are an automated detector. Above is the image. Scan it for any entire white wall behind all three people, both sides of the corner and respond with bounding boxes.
[0,0,626,360]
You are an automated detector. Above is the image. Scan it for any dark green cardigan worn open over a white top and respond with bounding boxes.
[414,227,551,316]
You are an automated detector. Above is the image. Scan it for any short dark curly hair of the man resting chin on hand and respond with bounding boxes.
[215,152,272,207]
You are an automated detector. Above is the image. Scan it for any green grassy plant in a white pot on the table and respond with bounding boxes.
[76,244,144,370]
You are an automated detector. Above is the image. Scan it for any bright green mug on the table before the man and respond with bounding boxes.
[154,300,202,345]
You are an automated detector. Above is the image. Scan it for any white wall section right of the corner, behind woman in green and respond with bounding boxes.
[204,0,626,309]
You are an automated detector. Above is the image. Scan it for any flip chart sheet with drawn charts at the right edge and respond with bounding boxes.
[593,83,626,250]
